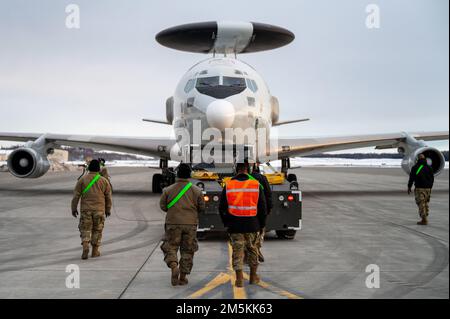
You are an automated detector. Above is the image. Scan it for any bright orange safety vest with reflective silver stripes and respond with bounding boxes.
[226,179,259,217]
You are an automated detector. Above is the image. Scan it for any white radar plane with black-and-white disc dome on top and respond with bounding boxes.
[0,21,449,192]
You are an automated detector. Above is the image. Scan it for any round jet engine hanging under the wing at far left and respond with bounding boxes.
[8,147,50,178]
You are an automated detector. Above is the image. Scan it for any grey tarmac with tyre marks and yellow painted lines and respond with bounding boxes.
[0,167,449,299]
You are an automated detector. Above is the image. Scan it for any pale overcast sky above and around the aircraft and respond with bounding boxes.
[0,0,449,149]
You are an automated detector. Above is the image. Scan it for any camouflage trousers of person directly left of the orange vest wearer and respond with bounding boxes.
[161,225,198,274]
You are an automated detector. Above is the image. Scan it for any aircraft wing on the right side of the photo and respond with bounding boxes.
[277,131,449,158]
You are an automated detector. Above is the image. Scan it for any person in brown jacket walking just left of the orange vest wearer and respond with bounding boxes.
[160,164,205,286]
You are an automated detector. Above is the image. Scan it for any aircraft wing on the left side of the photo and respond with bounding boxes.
[0,132,175,157]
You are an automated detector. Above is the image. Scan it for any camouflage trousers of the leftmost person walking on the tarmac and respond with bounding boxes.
[78,212,105,246]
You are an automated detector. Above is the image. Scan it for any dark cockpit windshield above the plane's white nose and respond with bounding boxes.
[195,76,246,99]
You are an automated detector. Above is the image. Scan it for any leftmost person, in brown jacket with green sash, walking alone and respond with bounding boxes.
[72,160,112,259]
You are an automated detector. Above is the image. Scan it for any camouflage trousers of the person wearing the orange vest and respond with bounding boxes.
[230,233,259,270]
